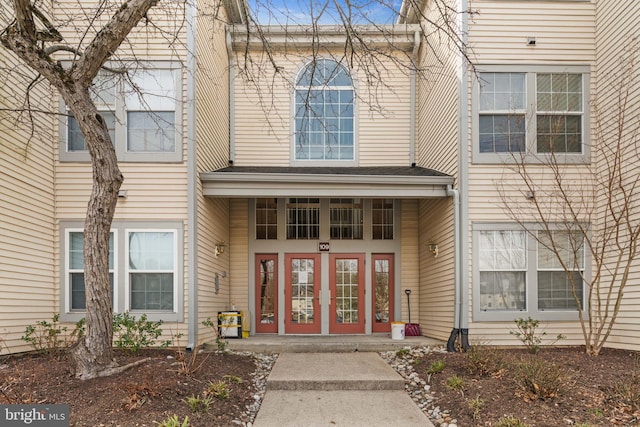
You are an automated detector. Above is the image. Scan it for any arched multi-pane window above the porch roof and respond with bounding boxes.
[293,59,355,161]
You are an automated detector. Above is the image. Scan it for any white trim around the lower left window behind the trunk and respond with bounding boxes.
[59,220,185,322]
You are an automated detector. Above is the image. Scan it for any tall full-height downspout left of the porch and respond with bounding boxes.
[186,0,198,351]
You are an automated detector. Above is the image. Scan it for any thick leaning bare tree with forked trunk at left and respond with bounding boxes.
[0,0,164,379]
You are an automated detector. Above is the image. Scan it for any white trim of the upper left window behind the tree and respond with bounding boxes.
[58,61,184,163]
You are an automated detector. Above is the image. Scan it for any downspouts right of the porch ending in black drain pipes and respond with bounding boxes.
[447,0,469,351]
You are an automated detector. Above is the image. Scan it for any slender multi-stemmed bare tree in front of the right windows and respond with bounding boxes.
[497,43,640,356]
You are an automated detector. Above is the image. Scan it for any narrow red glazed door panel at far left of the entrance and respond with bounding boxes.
[255,254,278,334]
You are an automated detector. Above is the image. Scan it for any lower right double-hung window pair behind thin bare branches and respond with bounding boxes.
[473,223,585,321]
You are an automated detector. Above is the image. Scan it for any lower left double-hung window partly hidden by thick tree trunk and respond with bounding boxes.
[60,221,183,321]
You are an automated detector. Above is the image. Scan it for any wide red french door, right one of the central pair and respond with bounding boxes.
[329,254,365,334]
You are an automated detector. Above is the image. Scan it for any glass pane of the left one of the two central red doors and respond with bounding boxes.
[291,258,315,324]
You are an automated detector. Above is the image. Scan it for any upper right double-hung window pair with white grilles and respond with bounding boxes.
[473,66,589,163]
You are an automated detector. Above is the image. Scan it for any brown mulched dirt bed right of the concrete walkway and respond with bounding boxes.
[413,347,640,427]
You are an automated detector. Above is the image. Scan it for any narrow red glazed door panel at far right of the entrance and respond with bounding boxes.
[371,254,394,332]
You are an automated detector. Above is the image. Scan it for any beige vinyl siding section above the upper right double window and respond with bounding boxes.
[469,0,595,64]
